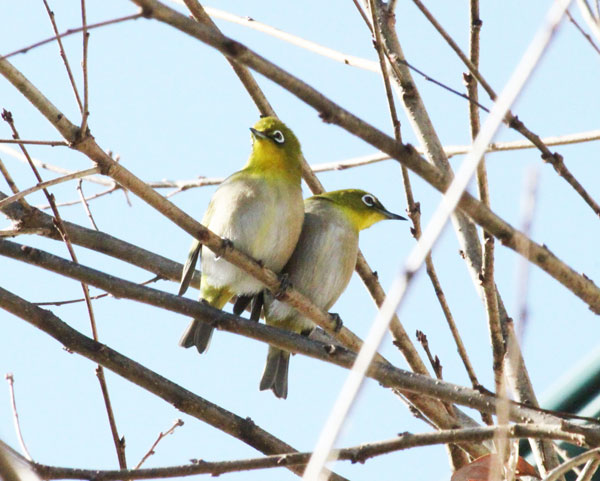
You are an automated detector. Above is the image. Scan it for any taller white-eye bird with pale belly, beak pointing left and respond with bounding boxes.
[179,117,304,353]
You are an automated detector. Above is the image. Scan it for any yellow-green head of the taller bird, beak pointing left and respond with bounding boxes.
[250,117,302,176]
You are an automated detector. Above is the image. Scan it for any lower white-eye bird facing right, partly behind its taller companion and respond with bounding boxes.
[260,189,406,399]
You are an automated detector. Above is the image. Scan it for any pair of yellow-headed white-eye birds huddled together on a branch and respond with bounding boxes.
[179,117,406,399]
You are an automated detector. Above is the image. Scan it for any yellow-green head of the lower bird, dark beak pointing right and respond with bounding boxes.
[314,189,406,230]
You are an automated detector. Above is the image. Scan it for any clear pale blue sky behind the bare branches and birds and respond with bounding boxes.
[0,0,600,480]
